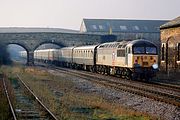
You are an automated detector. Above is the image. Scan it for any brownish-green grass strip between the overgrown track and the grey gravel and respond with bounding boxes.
[1,66,155,120]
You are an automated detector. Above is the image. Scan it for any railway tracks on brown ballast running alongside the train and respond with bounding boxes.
[43,67,180,107]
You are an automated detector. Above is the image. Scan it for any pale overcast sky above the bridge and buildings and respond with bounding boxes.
[0,0,180,30]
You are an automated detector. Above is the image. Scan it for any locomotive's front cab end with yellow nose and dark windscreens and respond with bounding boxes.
[126,40,158,79]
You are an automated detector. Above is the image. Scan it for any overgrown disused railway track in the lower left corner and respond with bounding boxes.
[3,75,57,120]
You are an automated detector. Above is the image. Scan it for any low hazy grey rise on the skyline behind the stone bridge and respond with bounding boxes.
[0,27,79,33]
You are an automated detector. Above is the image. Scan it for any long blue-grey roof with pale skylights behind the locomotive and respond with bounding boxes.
[81,19,168,33]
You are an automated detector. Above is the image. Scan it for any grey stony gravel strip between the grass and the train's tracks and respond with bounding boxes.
[49,70,180,120]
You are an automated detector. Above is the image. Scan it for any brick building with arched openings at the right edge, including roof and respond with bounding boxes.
[160,16,180,72]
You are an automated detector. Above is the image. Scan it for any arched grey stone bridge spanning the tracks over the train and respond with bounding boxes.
[0,32,114,65]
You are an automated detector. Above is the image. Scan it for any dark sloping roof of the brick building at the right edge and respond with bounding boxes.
[160,16,180,29]
